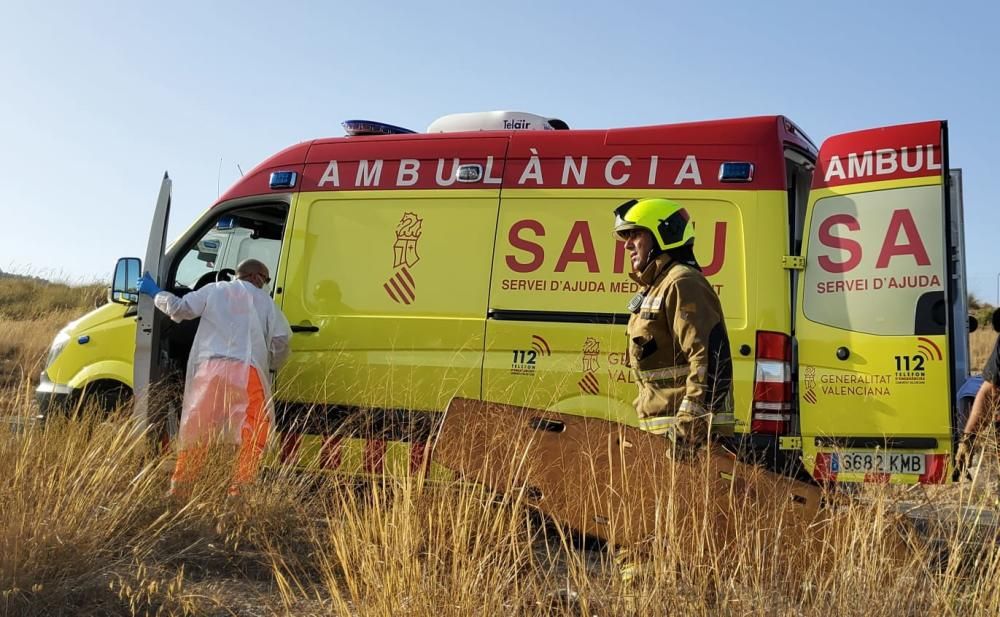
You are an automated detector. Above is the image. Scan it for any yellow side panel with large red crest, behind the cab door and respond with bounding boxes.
[279,190,499,410]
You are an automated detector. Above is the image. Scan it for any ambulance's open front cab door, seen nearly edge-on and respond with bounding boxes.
[132,172,173,429]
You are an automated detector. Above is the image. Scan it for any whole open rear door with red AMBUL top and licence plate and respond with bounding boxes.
[796,121,952,483]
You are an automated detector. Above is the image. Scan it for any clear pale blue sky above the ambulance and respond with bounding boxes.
[0,0,1000,302]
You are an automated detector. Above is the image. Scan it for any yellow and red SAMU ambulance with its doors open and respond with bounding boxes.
[38,112,968,483]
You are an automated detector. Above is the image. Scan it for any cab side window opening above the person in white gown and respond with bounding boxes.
[174,211,285,289]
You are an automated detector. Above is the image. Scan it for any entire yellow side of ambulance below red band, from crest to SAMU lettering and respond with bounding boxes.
[276,189,791,446]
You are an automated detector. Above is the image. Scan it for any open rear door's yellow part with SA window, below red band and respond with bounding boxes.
[797,170,952,484]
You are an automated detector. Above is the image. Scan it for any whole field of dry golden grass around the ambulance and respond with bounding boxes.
[0,282,1000,617]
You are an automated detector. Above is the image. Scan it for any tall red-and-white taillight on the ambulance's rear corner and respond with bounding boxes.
[750,332,792,435]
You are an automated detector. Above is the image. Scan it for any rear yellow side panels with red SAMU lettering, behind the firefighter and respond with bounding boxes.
[483,189,791,432]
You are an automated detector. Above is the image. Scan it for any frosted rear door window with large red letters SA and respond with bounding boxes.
[803,186,944,335]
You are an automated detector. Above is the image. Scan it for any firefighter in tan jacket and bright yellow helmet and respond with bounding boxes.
[615,199,734,451]
